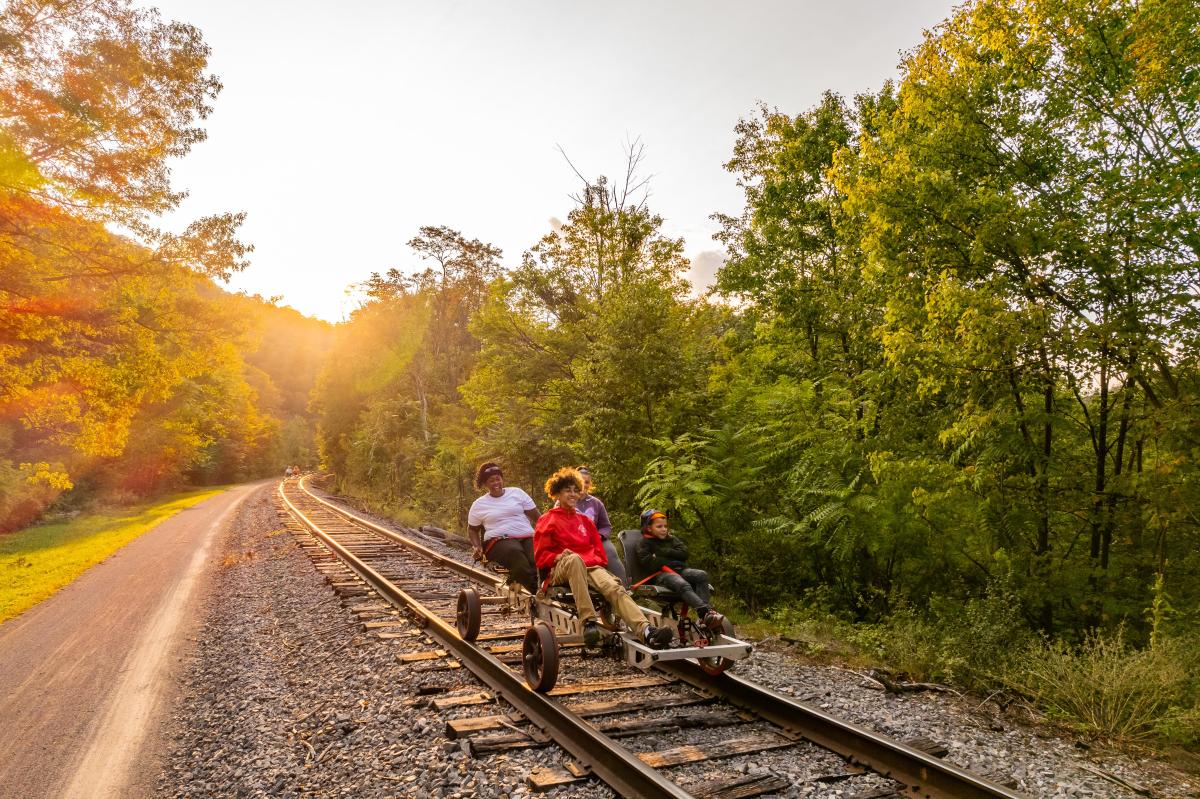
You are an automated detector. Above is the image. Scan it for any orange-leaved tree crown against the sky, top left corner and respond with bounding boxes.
[0,0,221,220]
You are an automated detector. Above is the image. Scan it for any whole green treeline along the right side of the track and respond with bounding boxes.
[314,0,1200,641]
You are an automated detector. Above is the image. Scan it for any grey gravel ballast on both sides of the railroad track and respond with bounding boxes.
[160,487,1200,799]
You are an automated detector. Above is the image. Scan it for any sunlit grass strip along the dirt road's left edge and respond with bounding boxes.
[0,488,224,621]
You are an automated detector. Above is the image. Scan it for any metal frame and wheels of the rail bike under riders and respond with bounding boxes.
[456,565,754,692]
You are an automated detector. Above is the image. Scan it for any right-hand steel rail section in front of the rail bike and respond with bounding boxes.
[655,661,1028,799]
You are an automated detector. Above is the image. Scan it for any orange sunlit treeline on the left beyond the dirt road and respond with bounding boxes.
[0,0,329,531]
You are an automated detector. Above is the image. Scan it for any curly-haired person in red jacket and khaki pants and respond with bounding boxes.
[533,468,672,649]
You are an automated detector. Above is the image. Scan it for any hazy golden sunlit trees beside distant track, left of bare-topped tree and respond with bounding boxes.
[316,227,500,523]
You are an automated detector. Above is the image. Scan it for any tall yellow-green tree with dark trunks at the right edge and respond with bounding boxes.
[838,0,1200,623]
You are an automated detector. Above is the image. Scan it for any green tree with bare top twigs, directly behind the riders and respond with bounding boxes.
[463,150,720,512]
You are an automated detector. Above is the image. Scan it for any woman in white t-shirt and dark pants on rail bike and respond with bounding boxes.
[467,463,538,593]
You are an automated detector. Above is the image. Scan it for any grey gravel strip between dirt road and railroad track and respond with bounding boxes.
[158,488,612,799]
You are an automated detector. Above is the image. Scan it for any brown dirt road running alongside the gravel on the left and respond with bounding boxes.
[0,482,274,799]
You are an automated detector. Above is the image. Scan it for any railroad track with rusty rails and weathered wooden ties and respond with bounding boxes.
[278,477,1024,799]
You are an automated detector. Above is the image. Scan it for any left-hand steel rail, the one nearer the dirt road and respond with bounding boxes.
[278,483,691,799]
